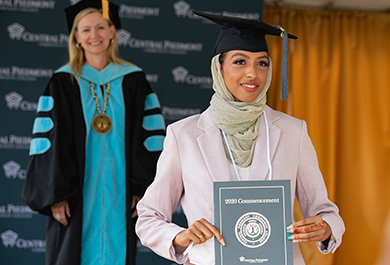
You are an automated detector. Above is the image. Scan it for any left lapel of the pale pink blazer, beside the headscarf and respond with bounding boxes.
[197,110,231,181]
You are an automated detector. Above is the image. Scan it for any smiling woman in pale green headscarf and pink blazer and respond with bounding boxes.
[136,11,344,265]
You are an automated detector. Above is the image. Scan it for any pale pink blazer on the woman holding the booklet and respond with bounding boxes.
[136,106,345,265]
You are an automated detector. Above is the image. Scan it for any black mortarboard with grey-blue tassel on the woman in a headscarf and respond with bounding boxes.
[193,10,297,100]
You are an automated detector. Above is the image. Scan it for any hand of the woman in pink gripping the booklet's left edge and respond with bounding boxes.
[173,218,225,247]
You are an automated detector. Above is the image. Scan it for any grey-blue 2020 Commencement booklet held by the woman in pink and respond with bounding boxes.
[214,180,294,265]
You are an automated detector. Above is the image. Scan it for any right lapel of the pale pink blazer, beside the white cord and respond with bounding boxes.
[249,106,281,180]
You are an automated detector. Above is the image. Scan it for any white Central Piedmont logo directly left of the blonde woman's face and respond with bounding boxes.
[7,22,69,48]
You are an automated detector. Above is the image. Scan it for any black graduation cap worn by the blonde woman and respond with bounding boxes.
[64,0,121,32]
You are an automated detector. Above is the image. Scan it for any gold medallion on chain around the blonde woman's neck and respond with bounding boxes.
[89,82,112,134]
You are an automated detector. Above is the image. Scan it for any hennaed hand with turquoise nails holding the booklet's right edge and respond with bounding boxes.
[287,216,332,243]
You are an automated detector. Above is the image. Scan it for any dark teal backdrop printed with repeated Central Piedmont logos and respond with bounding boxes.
[0,0,263,265]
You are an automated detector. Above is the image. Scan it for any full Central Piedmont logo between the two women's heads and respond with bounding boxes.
[117,29,203,55]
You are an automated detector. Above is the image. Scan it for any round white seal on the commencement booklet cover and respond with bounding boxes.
[235,212,271,248]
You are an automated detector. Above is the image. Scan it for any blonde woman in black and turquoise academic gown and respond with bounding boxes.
[22,0,165,265]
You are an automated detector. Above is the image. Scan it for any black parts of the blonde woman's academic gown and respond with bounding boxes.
[22,64,165,265]
